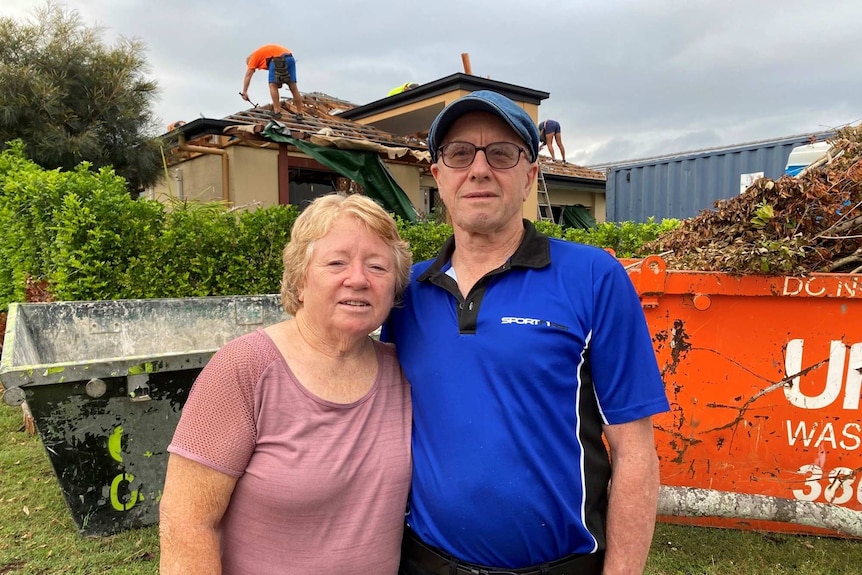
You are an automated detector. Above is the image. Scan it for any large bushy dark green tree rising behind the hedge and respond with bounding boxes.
[0,0,161,193]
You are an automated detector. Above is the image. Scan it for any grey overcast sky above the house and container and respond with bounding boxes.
[0,0,862,165]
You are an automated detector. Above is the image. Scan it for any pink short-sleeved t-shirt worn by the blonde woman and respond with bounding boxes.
[168,329,412,575]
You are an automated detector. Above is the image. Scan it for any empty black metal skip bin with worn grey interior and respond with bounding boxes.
[0,295,286,535]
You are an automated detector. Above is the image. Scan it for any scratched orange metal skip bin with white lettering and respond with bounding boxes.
[628,256,862,537]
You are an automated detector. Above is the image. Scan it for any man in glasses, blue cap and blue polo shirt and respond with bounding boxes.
[383,91,669,575]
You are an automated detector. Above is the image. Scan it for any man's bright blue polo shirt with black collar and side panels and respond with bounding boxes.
[383,220,669,568]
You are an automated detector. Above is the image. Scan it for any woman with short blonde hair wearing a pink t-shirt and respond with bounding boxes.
[160,195,418,575]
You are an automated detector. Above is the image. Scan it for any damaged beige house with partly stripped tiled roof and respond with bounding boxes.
[147,73,605,227]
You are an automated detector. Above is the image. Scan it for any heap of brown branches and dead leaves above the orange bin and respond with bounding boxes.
[645,127,862,276]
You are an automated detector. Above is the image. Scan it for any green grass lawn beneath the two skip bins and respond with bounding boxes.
[0,403,862,575]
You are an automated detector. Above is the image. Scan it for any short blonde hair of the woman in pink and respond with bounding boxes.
[281,194,413,315]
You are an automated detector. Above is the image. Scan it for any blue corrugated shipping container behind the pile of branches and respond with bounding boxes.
[605,132,834,222]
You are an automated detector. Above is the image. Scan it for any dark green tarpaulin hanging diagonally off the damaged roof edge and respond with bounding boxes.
[263,122,416,222]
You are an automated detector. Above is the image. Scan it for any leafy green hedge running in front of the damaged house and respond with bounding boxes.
[0,141,679,311]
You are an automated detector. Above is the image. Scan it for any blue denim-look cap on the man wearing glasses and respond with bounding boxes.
[428,90,539,163]
